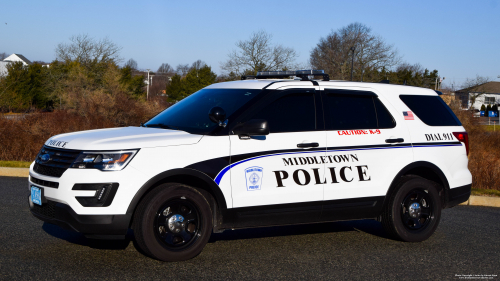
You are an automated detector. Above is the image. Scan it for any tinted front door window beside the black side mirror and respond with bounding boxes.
[246,93,316,133]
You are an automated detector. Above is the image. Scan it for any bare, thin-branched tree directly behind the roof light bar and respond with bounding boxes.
[221,30,297,76]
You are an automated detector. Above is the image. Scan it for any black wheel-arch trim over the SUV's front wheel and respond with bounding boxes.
[127,168,227,214]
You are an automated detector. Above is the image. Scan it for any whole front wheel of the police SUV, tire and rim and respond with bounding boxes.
[133,183,212,261]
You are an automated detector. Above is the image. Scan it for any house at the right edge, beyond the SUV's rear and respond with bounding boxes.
[455,82,500,110]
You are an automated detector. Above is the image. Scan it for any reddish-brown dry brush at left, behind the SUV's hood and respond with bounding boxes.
[0,96,168,161]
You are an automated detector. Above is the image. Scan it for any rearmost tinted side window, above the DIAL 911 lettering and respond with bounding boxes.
[399,95,462,126]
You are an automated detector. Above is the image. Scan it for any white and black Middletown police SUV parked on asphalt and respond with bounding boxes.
[29,71,472,261]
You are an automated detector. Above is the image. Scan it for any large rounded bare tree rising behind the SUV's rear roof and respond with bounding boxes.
[309,23,400,81]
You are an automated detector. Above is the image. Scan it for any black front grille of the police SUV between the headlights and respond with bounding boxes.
[33,146,80,178]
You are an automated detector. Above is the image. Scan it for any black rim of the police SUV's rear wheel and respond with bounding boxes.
[401,189,434,231]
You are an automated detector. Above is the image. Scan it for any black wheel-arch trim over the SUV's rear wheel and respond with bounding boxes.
[384,161,450,209]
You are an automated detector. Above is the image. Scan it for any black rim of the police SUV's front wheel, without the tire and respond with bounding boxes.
[153,198,201,251]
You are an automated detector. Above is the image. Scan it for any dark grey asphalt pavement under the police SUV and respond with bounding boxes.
[0,177,500,280]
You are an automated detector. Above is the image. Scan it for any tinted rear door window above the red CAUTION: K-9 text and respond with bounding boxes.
[325,93,396,130]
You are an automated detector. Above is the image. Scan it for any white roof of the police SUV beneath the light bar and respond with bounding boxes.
[206,79,437,95]
